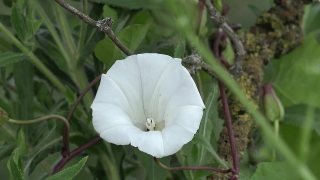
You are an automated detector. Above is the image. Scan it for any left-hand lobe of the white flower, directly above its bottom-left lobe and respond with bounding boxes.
[91,103,132,134]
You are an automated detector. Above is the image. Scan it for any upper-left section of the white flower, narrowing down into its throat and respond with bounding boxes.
[107,55,146,126]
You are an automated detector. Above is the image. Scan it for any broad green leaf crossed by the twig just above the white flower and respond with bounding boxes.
[94,24,149,68]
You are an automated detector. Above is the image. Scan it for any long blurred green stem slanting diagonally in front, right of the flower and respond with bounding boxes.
[165,0,317,180]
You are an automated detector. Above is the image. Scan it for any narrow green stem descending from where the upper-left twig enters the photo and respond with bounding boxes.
[53,3,75,56]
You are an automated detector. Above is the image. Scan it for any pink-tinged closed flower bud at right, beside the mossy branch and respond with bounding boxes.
[261,83,284,122]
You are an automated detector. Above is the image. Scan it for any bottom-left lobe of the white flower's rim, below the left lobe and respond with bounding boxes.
[100,125,142,145]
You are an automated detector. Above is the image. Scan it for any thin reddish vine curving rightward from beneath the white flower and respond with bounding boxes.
[153,157,234,174]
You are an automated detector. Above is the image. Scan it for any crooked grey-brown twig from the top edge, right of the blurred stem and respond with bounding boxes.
[202,0,245,79]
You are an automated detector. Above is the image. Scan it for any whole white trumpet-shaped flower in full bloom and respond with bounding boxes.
[91,54,204,158]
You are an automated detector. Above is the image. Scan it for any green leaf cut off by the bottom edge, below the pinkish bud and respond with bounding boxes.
[250,162,301,180]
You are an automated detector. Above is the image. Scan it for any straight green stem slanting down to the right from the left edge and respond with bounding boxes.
[0,23,64,92]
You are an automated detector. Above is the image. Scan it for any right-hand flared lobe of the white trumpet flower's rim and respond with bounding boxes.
[165,106,203,134]
